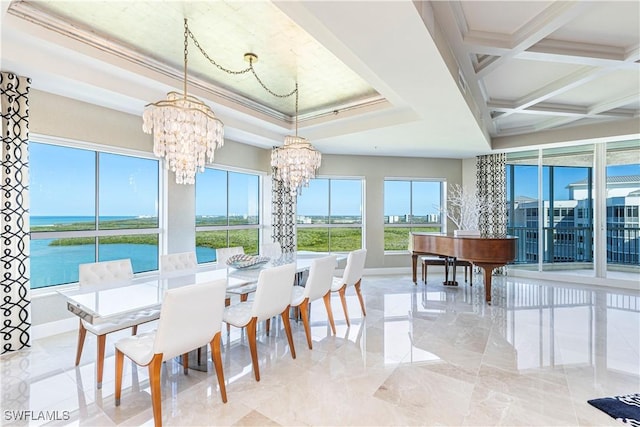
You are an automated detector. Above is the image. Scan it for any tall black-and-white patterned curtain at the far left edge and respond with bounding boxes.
[0,71,31,354]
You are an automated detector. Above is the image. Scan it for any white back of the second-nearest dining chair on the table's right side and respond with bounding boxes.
[251,264,296,321]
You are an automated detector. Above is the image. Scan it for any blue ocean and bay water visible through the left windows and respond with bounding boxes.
[30,216,216,289]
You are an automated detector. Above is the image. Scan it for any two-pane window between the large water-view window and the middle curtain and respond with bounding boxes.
[196,168,260,263]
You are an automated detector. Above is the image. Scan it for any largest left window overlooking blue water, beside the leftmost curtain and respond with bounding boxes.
[29,141,159,288]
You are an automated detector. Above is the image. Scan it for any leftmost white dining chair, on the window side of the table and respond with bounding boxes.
[76,259,160,388]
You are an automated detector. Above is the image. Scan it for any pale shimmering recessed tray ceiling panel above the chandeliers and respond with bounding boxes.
[22,0,377,116]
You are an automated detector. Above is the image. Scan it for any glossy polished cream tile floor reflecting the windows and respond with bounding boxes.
[0,274,640,426]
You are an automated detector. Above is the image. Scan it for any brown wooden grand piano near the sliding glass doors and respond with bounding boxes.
[409,233,517,302]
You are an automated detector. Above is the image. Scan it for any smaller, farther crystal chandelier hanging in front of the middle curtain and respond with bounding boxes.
[271,83,321,197]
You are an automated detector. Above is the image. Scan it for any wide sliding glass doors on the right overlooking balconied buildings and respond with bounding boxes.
[507,140,640,280]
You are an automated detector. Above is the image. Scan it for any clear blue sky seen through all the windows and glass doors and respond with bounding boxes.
[29,142,640,216]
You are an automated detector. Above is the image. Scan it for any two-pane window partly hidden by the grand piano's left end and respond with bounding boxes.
[384,179,443,251]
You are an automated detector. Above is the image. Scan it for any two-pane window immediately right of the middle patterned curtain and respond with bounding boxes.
[297,178,363,252]
